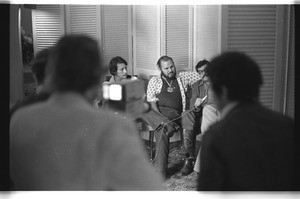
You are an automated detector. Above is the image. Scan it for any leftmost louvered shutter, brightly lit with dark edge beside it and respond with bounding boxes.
[32,5,65,53]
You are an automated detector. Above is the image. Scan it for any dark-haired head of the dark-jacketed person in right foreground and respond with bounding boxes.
[207,52,263,102]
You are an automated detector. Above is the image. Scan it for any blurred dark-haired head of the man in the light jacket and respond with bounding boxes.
[47,35,105,93]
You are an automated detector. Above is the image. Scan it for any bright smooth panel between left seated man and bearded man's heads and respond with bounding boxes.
[133,5,160,79]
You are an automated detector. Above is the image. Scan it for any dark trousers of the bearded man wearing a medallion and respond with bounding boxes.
[141,107,197,175]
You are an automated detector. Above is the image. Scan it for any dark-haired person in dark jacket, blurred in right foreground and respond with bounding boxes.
[198,52,295,191]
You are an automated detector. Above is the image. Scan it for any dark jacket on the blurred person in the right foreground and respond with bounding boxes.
[198,103,295,191]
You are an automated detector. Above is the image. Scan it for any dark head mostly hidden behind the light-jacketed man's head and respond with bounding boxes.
[32,48,51,85]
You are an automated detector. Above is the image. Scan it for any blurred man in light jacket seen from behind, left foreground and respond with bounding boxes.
[10,35,162,191]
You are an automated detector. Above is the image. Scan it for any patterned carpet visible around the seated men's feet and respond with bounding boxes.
[145,141,201,191]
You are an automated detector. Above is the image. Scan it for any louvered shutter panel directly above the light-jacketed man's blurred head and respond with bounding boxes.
[66,5,101,41]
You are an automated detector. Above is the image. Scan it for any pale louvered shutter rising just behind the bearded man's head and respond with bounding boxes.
[165,5,191,71]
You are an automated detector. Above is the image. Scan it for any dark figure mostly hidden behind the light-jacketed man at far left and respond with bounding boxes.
[10,48,50,118]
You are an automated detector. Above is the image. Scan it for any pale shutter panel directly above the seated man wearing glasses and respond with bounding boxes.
[193,5,220,65]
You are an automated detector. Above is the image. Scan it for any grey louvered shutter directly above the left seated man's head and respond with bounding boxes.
[101,5,132,74]
